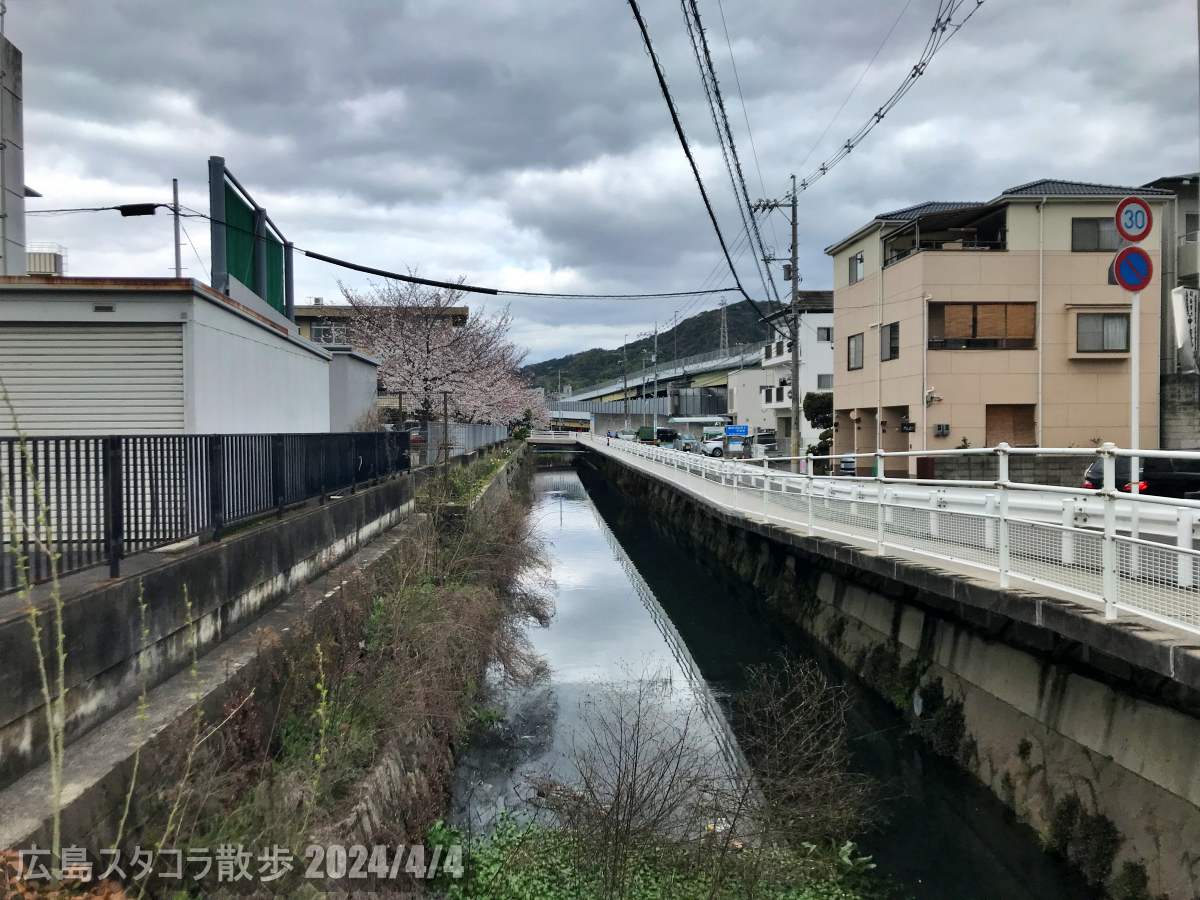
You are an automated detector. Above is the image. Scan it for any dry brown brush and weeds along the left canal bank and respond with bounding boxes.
[118,457,551,894]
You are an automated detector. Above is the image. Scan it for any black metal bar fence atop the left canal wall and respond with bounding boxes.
[0,432,409,593]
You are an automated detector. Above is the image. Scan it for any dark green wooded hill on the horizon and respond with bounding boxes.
[522,300,767,392]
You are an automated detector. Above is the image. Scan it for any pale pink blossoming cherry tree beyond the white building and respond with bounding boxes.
[341,281,550,425]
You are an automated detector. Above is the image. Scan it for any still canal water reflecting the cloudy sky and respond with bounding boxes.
[452,469,1090,900]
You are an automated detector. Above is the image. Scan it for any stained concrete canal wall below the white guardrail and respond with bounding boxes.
[586,452,1200,898]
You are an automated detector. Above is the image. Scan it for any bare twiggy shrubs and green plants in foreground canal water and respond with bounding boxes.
[444,659,887,900]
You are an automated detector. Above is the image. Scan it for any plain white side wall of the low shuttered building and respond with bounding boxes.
[184,300,330,434]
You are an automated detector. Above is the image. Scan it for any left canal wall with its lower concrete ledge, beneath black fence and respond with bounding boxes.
[0,450,524,848]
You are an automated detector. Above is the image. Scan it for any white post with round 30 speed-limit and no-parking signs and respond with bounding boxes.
[1105,197,1154,578]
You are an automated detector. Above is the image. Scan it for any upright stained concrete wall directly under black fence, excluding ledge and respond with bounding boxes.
[0,449,511,787]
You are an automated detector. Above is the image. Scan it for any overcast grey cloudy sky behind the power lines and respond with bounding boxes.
[5,0,1200,361]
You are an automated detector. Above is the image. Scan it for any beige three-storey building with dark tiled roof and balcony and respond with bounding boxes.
[826,179,1174,474]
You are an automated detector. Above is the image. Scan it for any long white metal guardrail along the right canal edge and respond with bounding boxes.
[589,436,1200,634]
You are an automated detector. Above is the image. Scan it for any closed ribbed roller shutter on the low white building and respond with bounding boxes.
[0,324,184,436]
